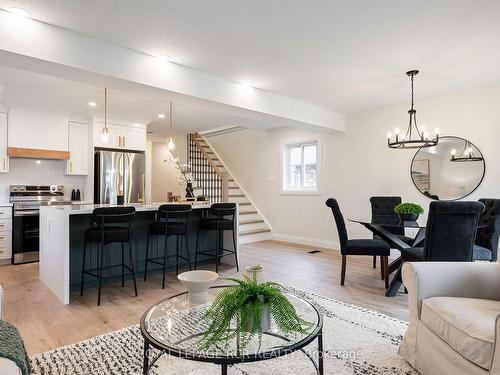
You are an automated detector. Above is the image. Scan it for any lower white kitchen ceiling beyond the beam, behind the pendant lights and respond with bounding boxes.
[0,65,278,140]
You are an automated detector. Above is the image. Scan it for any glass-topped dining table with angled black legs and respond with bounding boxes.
[349,219,426,297]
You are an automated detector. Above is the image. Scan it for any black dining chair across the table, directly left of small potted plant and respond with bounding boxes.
[370,196,414,274]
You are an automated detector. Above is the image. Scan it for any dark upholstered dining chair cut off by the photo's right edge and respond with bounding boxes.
[474,198,500,262]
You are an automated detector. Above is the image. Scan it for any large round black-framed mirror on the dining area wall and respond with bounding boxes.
[410,137,485,200]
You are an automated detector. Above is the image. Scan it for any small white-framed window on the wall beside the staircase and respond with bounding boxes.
[283,141,319,193]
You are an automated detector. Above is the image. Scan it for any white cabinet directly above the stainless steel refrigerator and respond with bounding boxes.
[94,122,146,151]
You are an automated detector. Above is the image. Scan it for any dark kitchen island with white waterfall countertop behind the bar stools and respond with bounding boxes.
[39,202,239,304]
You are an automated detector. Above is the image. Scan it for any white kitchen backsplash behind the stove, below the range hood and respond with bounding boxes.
[0,158,86,203]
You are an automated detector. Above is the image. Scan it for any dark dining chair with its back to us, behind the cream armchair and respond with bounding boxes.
[401,201,484,262]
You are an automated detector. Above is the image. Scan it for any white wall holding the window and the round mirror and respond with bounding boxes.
[209,86,500,246]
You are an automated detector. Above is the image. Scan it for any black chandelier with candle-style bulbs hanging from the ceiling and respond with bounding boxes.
[387,70,439,149]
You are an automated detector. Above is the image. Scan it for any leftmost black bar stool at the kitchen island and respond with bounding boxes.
[80,207,137,306]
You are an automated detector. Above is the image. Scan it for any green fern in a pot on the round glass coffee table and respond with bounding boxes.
[199,272,310,350]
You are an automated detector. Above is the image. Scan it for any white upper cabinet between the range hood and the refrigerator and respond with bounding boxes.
[66,121,89,175]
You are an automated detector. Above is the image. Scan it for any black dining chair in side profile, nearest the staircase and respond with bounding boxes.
[326,198,391,288]
